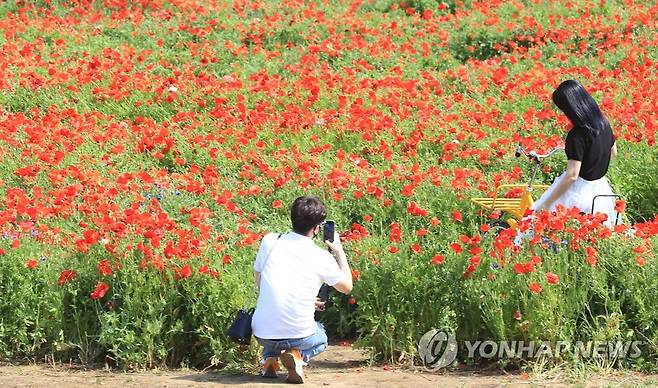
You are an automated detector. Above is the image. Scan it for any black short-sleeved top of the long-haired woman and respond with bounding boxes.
[564,127,615,181]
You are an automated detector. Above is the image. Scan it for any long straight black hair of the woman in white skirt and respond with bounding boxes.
[553,79,610,137]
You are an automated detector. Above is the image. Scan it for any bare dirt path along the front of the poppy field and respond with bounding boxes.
[0,346,658,388]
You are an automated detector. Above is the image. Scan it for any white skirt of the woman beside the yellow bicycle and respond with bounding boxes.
[532,173,621,226]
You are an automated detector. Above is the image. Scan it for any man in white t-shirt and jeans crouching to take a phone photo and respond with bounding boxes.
[252,196,352,383]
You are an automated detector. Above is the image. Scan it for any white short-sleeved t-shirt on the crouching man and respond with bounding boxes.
[251,232,344,339]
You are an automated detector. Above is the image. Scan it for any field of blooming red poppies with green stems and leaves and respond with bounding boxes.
[0,0,658,370]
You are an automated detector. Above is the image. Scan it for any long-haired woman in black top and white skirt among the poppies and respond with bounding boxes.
[533,80,617,225]
